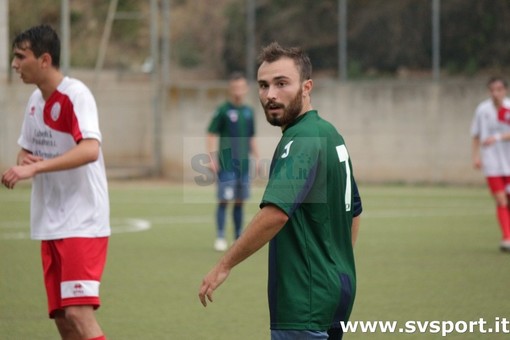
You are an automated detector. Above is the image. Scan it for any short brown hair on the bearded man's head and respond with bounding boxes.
[259,42,312,81]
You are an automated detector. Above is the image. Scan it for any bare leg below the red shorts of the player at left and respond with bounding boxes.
[55,306,103,340]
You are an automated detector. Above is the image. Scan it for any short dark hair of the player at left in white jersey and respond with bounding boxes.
[12,24,60,68]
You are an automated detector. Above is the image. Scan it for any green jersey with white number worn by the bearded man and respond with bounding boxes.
[261,111,356,330]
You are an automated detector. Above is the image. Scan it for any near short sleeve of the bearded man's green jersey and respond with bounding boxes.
[260,137,320,216]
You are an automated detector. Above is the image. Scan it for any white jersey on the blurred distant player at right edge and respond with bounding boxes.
[471,98,510,177]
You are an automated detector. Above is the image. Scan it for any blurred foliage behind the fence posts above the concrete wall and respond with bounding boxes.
[9,0,510,76]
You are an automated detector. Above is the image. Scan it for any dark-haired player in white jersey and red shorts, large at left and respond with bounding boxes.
[2,25,110,340]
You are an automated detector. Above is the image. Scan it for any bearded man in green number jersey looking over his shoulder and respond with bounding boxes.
[199,43,362,340]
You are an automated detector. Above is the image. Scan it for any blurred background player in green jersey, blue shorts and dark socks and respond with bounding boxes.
[207,72,258,251]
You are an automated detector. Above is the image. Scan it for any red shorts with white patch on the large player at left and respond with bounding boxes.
[41,237,108,318]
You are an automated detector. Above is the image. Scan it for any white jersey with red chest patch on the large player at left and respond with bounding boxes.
[18,77,110,240]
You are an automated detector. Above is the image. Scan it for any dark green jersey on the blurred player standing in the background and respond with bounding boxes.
[207,102,255,175]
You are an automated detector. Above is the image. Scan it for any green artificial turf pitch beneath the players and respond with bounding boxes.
[0,181,510,340]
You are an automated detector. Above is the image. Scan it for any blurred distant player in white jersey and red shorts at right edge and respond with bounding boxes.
[471,77,510,251]
